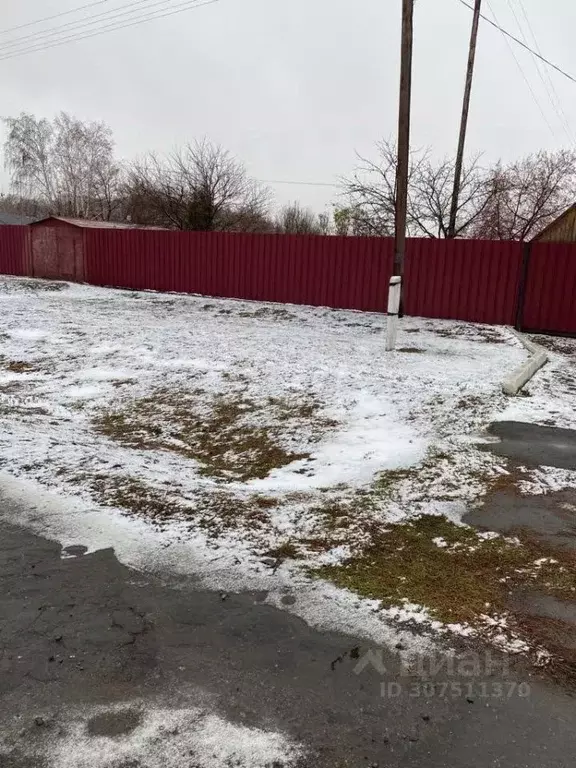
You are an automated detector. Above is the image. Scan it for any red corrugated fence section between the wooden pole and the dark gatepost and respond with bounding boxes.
[404,239,522,324]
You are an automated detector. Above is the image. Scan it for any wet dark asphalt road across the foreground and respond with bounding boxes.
[0,510,576,768]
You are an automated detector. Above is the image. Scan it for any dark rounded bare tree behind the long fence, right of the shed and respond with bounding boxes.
[127,139,269,231]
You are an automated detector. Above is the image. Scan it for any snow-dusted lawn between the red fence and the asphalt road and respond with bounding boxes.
[0,278,568,656]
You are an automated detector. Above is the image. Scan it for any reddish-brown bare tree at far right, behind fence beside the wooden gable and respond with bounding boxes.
[472,150,576,240]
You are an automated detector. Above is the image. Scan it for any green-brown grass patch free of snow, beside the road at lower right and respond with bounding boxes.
[316,515,576,624]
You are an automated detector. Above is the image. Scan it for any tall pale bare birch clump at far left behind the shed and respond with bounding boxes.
[4,112,120,219]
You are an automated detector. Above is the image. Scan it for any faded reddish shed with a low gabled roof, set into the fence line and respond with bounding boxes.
[29,216,164,282]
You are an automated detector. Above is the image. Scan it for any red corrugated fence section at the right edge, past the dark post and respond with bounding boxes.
[522,243,576,333]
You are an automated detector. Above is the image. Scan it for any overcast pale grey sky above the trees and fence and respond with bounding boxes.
[0,0,576,211]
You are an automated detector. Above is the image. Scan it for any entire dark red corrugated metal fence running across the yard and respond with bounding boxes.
[0,227,576,334]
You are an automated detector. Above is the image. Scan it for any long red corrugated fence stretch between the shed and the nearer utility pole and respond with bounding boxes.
[84,229,393,311]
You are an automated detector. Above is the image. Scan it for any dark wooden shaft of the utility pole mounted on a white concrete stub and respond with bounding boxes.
[394,0,414,276]
